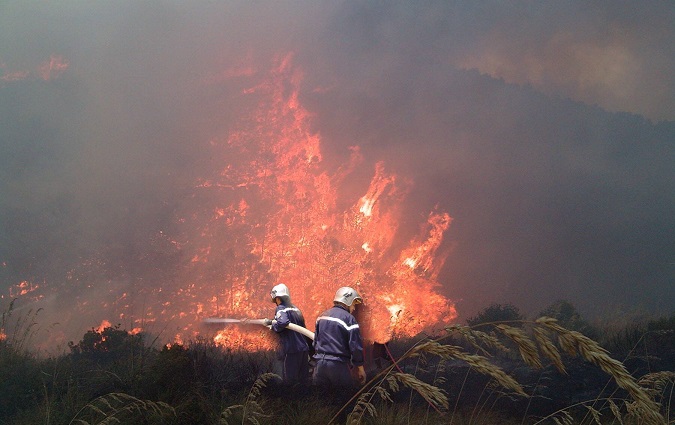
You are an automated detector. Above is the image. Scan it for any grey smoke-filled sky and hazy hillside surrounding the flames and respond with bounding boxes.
[0,0,675,338]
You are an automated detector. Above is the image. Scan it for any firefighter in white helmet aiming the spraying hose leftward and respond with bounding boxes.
[265,283,309,384]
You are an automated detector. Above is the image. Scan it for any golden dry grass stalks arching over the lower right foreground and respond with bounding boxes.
[328,317,675,424]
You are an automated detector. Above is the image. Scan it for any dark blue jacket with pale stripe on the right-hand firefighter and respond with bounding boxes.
[314,305,363,366]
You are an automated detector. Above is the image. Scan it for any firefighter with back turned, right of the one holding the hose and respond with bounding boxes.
[312,286,366,387]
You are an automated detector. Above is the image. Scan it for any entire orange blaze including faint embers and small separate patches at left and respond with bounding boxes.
[3,55,456,350]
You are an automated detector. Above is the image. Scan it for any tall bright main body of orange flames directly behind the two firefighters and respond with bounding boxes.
[178,56,456,347]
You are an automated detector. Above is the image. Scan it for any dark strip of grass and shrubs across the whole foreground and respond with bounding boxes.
[0,301,675,425]
